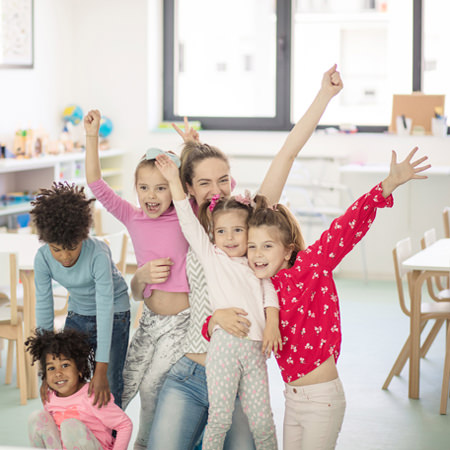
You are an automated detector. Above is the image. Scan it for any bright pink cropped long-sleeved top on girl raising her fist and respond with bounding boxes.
[89,179,189,298]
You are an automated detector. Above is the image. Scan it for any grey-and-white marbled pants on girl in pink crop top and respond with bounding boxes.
[122,305,190,450]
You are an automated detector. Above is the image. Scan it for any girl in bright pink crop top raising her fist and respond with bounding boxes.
[84,110,192,450]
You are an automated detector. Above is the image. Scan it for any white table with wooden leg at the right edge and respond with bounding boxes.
[403,239,450,398]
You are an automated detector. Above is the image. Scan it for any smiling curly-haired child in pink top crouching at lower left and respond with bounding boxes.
[25,329,132,450]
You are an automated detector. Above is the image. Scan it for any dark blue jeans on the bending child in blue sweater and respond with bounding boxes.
[64,311,130,407]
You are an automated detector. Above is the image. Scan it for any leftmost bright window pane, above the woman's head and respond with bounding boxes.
[174,0,276,117]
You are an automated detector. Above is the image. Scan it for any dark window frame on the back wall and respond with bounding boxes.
[163,0,423,133]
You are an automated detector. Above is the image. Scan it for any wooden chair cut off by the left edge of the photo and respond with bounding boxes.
[0,252,27,405]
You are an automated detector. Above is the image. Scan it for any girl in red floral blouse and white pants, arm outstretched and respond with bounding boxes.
[244,147,430,450]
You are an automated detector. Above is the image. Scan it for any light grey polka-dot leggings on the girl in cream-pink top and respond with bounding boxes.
[203,330,277,450]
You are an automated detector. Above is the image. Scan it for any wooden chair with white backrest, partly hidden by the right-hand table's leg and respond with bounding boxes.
[383,238,450,414]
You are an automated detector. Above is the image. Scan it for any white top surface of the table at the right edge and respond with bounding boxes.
[403,239,450,271]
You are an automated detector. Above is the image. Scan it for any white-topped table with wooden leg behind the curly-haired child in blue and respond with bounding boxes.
[0,233,42,398]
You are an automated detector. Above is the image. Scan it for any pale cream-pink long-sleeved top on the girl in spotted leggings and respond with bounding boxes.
[174,199,278,341]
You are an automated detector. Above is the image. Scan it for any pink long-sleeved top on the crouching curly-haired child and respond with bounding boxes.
[44,384,133,450]
